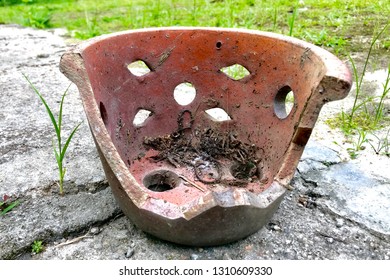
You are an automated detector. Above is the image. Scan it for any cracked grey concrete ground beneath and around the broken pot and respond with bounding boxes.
[0,25,390,260]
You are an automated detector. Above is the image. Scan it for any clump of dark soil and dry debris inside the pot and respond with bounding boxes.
[144,128,260,187]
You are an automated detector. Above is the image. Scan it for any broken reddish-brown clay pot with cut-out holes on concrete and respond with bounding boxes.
[60,28,351,246]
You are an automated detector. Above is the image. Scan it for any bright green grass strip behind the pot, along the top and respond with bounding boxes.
[0,0,390,54]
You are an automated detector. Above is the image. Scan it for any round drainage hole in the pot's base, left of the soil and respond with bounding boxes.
[143,170,180,192]
